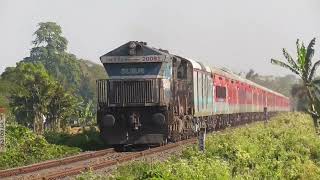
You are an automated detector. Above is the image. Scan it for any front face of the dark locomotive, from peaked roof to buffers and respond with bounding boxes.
[97,41,172,145]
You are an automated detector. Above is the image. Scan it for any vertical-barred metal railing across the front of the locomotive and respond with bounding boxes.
[97,79,160,106]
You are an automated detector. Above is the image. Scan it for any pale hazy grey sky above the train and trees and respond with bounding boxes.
[0,0,320,75]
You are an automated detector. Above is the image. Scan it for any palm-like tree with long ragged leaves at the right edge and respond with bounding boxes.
[271,38,320,132]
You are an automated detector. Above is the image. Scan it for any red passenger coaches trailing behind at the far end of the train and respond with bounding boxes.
[212,68,289,117]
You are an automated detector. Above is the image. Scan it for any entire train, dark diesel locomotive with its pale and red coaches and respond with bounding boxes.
[97,41,290,145]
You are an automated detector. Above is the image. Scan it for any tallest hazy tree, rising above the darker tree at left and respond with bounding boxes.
[23,22,82,93]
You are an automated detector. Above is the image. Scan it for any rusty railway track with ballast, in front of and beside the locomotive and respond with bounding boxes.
[0,138,197,179]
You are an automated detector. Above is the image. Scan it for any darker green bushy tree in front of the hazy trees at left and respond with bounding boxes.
[2,63,78,133]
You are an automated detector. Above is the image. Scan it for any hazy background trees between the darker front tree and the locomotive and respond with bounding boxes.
[23,22,106,102]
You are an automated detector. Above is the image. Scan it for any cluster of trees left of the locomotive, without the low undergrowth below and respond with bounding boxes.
[0,22,105,134]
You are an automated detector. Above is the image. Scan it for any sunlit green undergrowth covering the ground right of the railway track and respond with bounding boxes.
[79,113,320,179]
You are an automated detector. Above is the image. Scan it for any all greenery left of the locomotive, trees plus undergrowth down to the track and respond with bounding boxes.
[0,22,106,165]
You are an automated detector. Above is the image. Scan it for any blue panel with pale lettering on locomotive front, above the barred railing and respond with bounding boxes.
[104,62,162,76]
